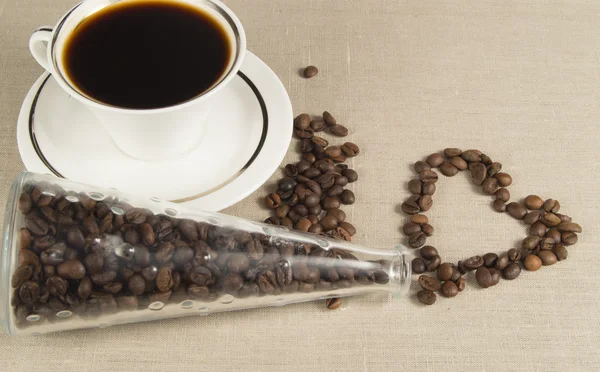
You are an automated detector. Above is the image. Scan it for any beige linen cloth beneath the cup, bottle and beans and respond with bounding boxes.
[0,0,600,372]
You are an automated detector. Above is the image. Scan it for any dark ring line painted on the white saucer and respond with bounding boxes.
[29,71,269,203]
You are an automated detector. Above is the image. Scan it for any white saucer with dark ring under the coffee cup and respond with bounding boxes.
[17,52,293,211]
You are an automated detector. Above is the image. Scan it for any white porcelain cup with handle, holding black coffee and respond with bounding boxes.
[29,0,246,161]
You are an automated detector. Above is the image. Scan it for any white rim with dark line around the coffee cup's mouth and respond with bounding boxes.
[48,0,246,115]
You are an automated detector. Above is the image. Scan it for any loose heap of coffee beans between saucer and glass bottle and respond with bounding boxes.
[265,111,360,308]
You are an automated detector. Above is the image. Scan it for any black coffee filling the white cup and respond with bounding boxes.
[64,1,232,109]
